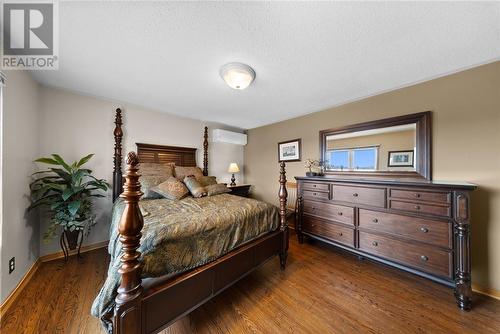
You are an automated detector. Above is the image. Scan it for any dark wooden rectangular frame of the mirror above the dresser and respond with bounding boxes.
[319,111,432,181]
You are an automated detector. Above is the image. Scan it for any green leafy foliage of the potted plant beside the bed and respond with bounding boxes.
[28,154,109,242]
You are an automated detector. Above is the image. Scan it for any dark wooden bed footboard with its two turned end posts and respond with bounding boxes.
[113,152,288,334]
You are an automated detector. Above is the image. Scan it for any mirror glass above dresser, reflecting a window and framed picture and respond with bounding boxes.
[324,123,418,172]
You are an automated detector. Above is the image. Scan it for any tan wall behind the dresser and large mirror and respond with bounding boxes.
[245,62,500,290]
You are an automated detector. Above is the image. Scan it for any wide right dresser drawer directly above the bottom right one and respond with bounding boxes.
[359,209,453,248]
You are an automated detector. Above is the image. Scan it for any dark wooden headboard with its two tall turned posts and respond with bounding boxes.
[113,108,208,201]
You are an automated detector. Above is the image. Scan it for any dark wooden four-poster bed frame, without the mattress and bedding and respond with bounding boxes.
[102,109,288,334]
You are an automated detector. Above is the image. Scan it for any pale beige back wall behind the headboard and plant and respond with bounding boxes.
[40,87,244,255]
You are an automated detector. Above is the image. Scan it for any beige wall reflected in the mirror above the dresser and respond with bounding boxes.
[326,130,415,171]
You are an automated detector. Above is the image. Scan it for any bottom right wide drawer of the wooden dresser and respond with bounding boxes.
[359,231,453,278]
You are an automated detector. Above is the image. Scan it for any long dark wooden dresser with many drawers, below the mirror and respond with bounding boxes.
[295,177,475,310]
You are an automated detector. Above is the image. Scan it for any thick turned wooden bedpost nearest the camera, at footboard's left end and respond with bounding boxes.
[113,152,144,334]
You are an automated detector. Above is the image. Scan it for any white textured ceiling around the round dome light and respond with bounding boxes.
[33,2,500,129]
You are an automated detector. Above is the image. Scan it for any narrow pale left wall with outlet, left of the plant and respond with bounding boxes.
[0,71,39,302]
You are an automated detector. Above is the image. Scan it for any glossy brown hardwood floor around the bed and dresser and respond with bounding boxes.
[1,238,500,334]
